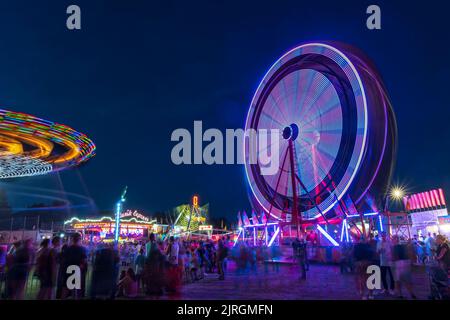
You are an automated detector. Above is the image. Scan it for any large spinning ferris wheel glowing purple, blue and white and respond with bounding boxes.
[245,43,396,223]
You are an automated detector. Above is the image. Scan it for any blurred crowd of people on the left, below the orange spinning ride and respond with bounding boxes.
[0,234,236,299]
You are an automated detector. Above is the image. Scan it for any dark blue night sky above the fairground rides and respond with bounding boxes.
[0,0,450,217]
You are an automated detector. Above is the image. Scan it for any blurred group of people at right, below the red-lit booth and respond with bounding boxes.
[340,232,450,299]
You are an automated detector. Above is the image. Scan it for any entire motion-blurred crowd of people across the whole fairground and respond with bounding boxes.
[0,233,450,299]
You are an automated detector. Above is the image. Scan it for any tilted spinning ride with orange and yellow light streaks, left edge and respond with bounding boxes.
[0,109,95,179]
